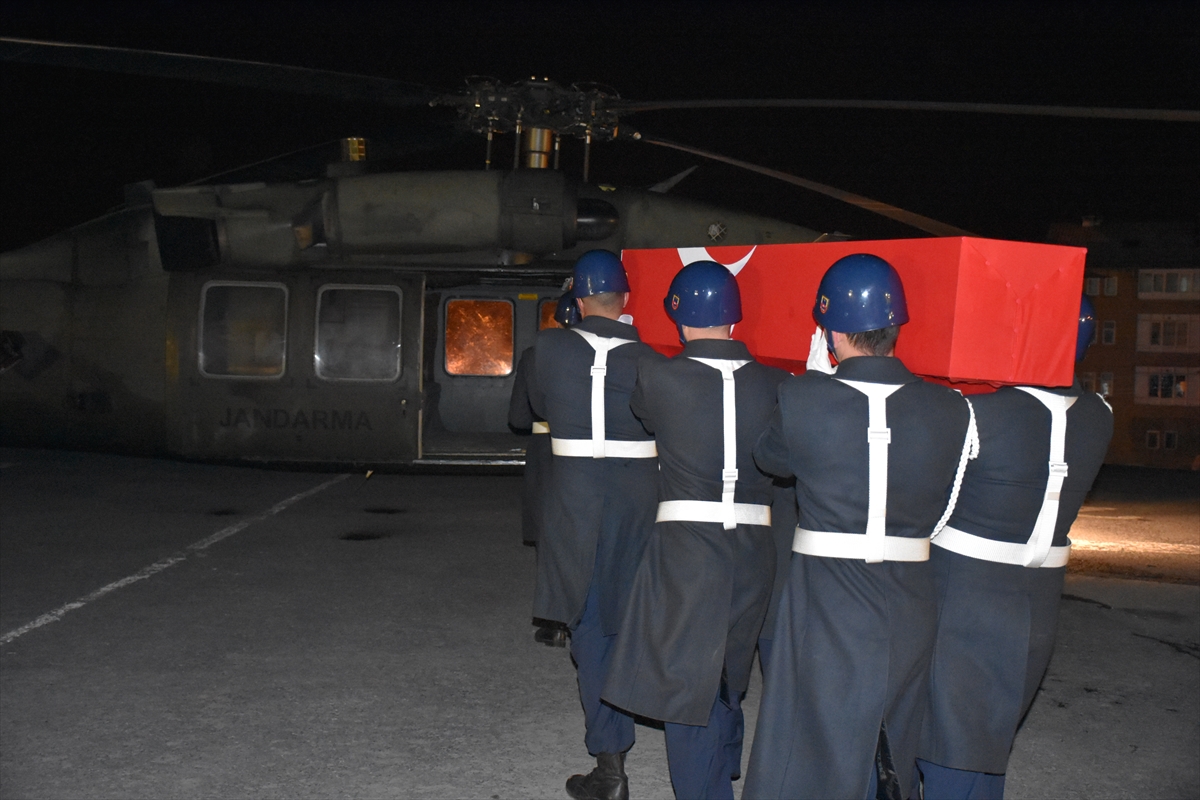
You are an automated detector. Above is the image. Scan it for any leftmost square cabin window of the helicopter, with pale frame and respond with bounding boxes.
[199,282,288,378]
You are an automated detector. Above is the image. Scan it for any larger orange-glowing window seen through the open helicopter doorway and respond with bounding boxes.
[445,300,512,375]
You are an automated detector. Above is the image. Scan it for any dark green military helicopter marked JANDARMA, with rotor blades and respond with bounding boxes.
[0,38,1200,465]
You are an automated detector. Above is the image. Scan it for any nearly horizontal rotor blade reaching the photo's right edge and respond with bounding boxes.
[611,98,1200,122]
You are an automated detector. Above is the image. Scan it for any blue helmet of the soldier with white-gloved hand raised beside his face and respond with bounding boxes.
[812,253,908,333]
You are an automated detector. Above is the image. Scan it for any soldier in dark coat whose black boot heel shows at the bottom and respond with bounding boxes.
[529,251,662,799]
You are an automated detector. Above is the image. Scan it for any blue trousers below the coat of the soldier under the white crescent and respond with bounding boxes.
[662,681,745,800]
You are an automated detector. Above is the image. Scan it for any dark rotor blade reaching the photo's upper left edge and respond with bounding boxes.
[0,37,438,107]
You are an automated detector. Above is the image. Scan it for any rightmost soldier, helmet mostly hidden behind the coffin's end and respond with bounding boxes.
[917,296,1112,800]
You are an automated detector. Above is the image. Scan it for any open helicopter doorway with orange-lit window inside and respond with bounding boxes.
[422,285,560,464]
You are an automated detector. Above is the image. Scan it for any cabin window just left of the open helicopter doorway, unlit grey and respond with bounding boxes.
[313,284,401,380]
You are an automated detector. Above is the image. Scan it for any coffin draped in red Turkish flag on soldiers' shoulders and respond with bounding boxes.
[622,236,1086,391]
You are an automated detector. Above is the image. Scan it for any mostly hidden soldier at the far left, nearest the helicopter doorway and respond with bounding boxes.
[509,291,580,648]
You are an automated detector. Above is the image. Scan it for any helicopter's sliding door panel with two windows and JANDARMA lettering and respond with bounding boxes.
[167,271,424,464]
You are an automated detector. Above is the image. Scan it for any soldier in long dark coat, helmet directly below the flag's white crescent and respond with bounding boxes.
[604,261,787,800]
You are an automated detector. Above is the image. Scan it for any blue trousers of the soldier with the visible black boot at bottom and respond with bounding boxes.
[571,575,634,756]
